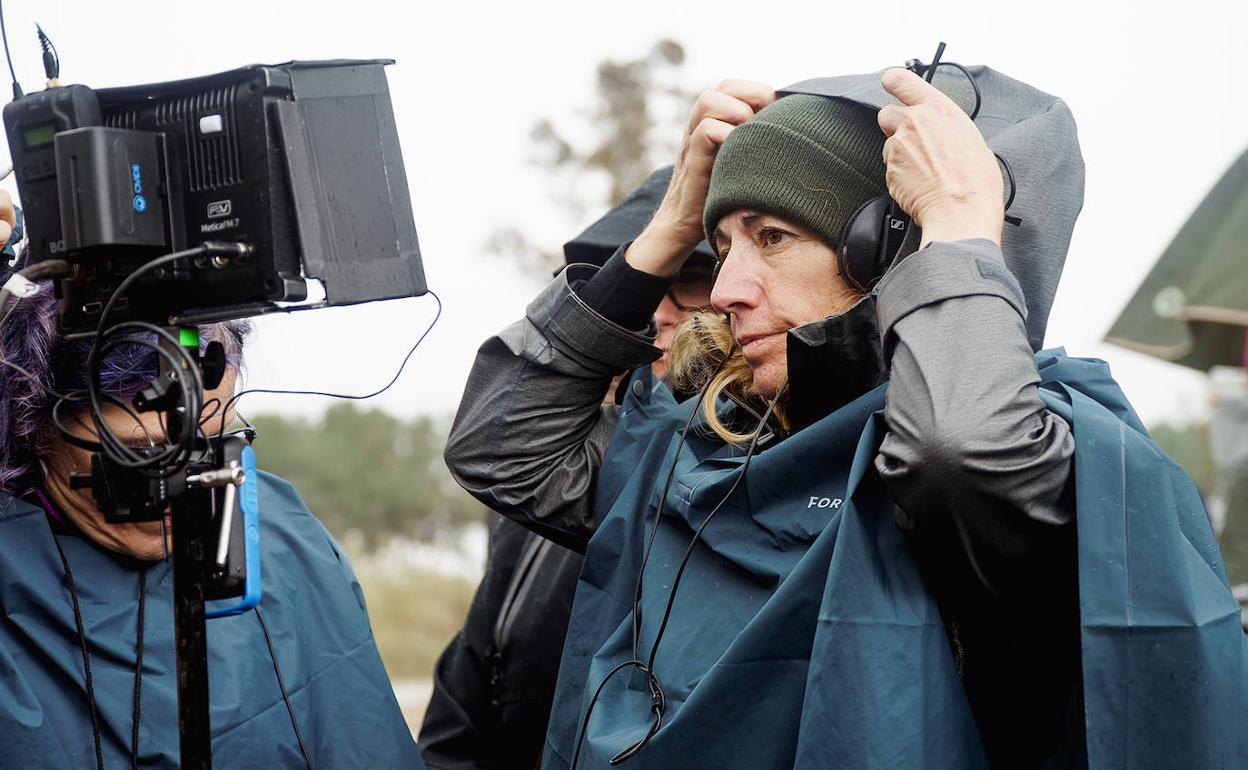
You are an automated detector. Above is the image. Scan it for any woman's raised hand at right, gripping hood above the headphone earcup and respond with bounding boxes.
[879,69,1005,246]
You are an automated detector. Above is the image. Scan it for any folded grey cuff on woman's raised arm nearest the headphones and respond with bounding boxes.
[874,238,1027,348]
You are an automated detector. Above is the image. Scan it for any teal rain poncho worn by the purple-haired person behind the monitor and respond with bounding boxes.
[0,474,423,770]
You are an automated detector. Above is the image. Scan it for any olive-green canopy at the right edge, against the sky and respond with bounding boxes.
[1106,147,1248,372]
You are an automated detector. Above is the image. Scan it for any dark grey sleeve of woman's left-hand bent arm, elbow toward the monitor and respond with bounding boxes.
[446,255,661,552]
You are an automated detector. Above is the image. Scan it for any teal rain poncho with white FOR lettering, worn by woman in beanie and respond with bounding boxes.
[543,352,1248,770]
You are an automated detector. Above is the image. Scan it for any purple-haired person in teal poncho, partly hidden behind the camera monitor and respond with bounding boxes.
[0,191,424,770]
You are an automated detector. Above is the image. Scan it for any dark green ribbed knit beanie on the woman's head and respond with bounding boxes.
[703,94,889,248]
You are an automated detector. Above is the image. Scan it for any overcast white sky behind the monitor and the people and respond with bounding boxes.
[0,0,1248,422]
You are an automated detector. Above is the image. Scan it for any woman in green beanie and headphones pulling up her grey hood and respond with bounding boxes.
[446,67,1248,770]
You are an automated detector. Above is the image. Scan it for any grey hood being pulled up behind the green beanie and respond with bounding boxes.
[780,66,1083,351]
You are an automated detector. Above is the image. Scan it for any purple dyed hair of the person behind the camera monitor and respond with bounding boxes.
[0,275,251,494]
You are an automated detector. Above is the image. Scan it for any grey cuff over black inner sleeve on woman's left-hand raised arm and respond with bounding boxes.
[525,265,663,372]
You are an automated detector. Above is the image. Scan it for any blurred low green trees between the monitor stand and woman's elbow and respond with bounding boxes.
[252,403,482,548]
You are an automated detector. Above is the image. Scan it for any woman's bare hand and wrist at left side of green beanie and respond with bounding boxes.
[624,80,776,276]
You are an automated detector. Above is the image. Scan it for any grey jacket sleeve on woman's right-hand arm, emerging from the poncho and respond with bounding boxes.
[876,241,1075,594]
